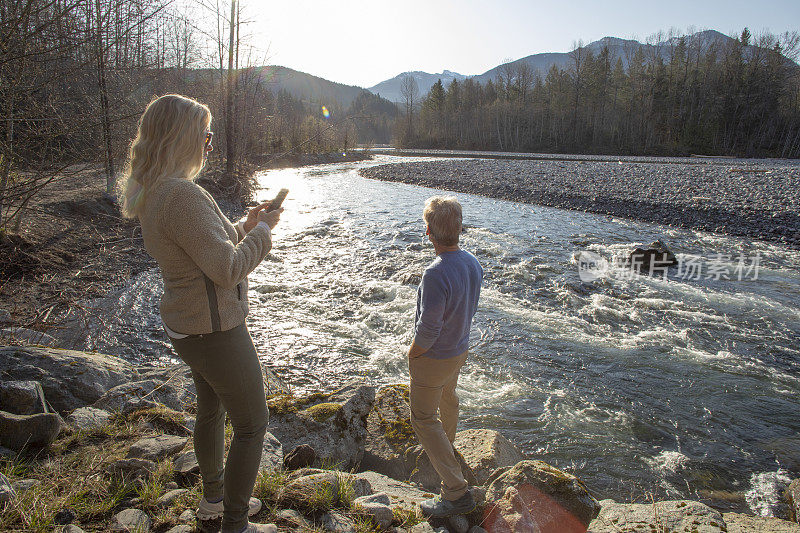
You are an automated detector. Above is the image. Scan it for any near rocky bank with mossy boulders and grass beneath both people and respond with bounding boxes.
[0,347,800,533]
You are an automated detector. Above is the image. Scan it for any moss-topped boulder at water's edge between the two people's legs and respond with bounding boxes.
[269,382,375,470]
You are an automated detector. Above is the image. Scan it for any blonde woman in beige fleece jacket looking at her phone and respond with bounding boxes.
[122,94,282,532]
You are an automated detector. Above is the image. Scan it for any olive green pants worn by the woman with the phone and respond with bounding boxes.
[171,324,269,531]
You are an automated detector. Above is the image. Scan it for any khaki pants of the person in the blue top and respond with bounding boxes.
[408,352,468,500]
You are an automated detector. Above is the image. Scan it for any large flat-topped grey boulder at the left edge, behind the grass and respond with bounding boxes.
[0,346,136,412]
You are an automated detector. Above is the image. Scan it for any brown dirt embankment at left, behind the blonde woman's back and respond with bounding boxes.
[0,167,155,330]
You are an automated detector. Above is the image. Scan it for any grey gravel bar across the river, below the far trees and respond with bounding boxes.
[361,156,800,248]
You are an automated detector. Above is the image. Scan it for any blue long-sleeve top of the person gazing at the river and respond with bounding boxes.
[414,250,483,359]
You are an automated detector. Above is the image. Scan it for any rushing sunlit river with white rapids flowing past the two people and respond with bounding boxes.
[64,156,800,515]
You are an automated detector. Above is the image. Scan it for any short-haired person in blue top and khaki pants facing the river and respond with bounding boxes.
[408,196,483,517]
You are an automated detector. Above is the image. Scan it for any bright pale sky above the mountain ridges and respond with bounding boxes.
[247,0,800,87]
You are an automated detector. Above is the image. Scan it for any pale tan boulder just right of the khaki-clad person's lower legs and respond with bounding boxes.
[453,429,525,485]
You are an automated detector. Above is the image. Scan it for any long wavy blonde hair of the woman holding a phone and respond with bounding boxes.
[119,94,211,218]
